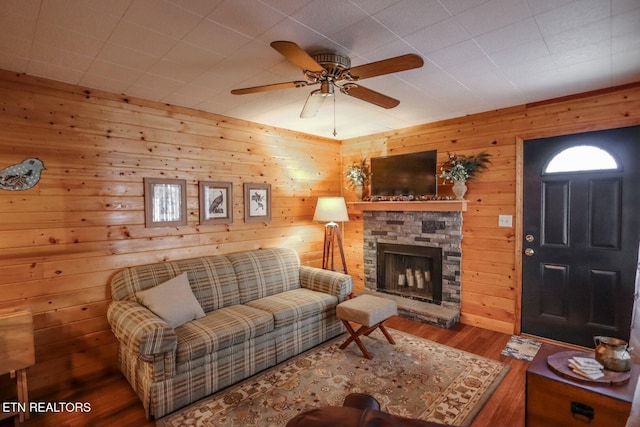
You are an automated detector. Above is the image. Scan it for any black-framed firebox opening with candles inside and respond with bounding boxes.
[376,243,442,304]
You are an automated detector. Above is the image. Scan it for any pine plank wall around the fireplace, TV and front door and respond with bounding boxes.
[342,84,640,333]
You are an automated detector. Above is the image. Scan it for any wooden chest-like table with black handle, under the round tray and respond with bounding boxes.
[525,344,640,427]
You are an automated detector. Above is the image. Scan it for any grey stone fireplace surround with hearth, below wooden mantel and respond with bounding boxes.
[363,209,462,328]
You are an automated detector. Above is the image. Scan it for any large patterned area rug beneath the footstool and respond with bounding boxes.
[157,329,509,427]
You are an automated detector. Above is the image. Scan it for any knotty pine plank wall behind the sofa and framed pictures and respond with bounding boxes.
[0,71,341,397]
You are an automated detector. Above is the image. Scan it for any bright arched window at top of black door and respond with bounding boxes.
[544,145,620,174]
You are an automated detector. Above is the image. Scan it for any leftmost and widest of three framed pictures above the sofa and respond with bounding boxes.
[144,178,187,227]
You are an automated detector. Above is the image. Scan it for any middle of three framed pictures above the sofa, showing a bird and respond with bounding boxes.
[198,181,233,225]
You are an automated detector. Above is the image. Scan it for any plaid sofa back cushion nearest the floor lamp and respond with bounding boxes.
[227,248,300,304]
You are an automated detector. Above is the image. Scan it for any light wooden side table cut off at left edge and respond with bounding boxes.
[0,309,35,422]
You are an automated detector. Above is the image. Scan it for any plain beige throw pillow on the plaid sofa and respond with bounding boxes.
[136,273,205,328]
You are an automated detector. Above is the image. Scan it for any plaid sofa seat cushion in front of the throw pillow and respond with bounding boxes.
[176,305,273,365]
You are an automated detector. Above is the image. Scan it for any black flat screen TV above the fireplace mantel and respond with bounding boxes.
[371,150,438,198]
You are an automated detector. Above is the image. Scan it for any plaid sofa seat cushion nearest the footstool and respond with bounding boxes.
[246,288,338,328]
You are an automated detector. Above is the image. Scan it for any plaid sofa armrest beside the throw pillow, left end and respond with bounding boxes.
[107,301,178,361]
